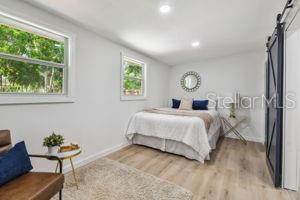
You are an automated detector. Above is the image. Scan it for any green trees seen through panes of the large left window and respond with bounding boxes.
[0,24,65,94]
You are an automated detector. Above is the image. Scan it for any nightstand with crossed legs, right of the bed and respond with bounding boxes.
[221,117,247,144]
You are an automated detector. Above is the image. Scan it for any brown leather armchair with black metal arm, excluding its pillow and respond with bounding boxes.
[0,130,64,200]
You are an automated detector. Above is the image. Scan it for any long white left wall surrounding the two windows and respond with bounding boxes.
[0,0,170,169]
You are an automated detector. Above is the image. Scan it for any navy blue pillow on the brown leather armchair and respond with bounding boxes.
[0,142,32,186]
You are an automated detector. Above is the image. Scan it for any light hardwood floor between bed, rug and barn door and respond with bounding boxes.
[107,138,290,200]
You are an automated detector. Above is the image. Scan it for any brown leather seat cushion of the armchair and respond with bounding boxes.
[0,172,64,200]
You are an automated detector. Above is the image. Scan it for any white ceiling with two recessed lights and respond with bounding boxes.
[25,0,286,65]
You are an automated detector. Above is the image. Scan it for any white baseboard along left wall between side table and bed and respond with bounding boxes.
[63,142,130,173]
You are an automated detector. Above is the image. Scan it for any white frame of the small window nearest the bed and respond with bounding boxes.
[120,52,147,101]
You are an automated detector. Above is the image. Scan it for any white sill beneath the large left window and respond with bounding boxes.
[0,95,75,105]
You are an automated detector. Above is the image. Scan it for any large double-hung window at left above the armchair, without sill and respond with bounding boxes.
[0,14,69,97]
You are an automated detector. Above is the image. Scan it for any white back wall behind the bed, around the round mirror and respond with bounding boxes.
[170,50,266,142]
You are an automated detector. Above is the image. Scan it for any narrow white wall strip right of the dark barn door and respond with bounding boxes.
[283,9,300,190]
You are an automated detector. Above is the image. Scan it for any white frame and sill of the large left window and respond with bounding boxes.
[0,11,75,105]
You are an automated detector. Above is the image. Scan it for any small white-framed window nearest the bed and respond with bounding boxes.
[121,56,146,100]
